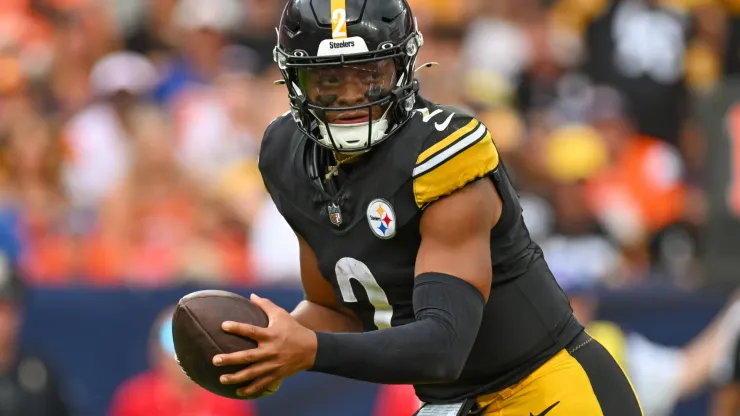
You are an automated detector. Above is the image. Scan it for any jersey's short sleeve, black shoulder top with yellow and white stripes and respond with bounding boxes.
[413,116,499,208]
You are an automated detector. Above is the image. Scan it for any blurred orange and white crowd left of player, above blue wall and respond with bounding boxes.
[0,0,295,286]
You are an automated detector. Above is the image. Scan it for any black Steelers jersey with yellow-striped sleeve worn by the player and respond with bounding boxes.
[259,97,582,403]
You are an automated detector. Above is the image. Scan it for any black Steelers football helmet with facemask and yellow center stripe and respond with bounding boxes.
[274,0,424,153]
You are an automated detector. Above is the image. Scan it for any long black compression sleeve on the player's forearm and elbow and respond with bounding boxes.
[311,273,485,384]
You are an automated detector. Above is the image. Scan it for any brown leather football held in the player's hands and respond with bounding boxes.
[172,290,268,399]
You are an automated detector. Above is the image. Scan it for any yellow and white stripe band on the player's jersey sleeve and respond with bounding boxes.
[414,124,499,208]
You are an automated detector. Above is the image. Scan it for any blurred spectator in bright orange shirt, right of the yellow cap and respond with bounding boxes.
[585,87,687,282]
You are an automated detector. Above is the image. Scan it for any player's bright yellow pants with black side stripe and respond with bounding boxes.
[477,333,642,416]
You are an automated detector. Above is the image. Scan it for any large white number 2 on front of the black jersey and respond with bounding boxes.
[334,257,393,329]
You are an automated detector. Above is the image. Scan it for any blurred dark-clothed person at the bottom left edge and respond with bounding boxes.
[0,257,72,416]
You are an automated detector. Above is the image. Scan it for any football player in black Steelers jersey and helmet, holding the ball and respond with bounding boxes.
[213,0,642,416]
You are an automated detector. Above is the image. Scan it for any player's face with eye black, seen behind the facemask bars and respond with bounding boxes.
[299,59,396,124]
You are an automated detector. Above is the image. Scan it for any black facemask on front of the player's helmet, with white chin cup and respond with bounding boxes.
[275,31,423,153]
